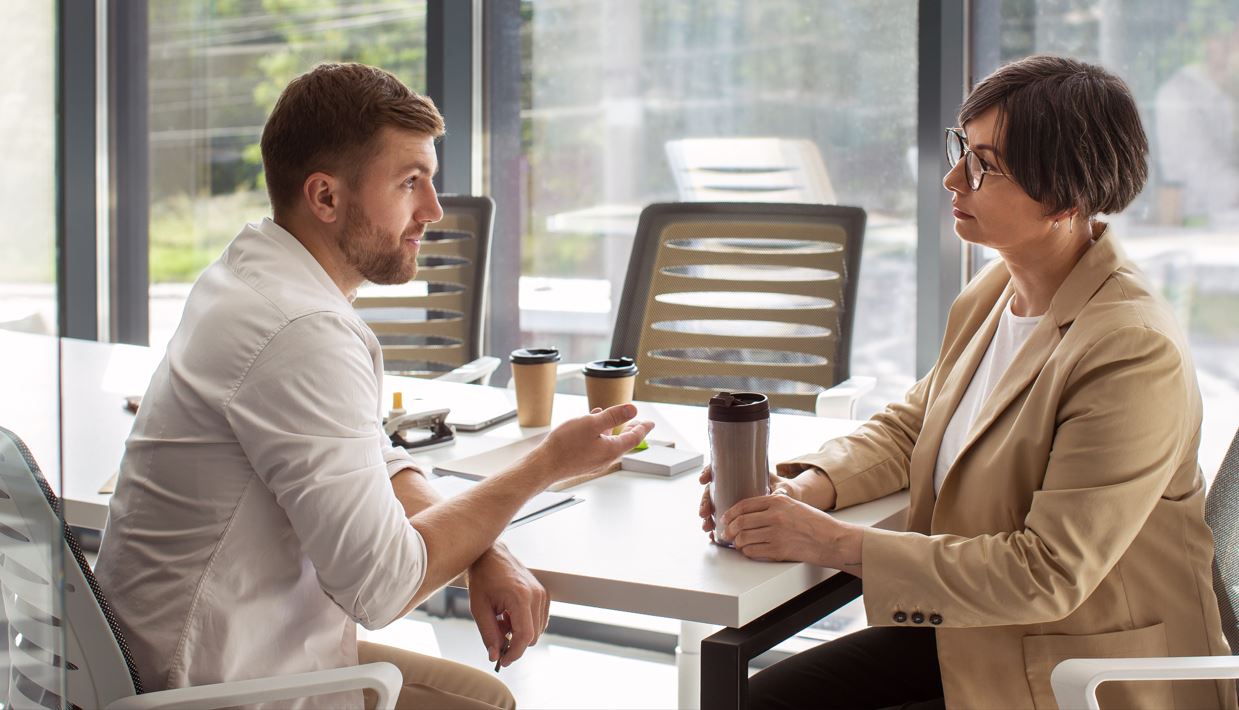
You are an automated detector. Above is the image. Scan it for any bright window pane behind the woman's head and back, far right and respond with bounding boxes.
[973,0,1239,480]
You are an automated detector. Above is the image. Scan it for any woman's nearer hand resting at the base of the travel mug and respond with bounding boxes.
[722,493,865,576]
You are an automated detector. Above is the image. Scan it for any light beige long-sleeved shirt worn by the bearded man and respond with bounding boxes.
[97,219,426,708]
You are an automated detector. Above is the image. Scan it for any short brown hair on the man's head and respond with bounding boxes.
[261,64,444,212]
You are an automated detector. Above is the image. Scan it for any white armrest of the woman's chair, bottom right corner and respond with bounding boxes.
[1049,655,1239,710]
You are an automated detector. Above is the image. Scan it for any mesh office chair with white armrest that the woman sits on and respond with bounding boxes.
[1049,423,1239,710]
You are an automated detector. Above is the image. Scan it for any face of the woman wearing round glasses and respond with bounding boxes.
[942,107,1067,252]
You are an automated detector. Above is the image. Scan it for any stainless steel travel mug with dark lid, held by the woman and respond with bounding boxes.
[709,392,771,548]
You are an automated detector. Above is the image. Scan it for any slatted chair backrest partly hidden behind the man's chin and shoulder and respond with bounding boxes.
[353,195,494,377]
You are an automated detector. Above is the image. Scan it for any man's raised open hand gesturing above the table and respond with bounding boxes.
[527,404,654,486]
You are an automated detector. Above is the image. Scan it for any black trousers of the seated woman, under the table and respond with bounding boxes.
[748,627,945,710]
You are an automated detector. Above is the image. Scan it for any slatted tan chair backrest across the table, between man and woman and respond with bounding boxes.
[611,202,865,411]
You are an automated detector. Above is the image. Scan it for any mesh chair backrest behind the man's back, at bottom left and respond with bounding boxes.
[0,427,142,709]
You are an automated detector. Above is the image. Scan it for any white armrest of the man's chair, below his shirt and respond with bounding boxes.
[108,662,404,710]
